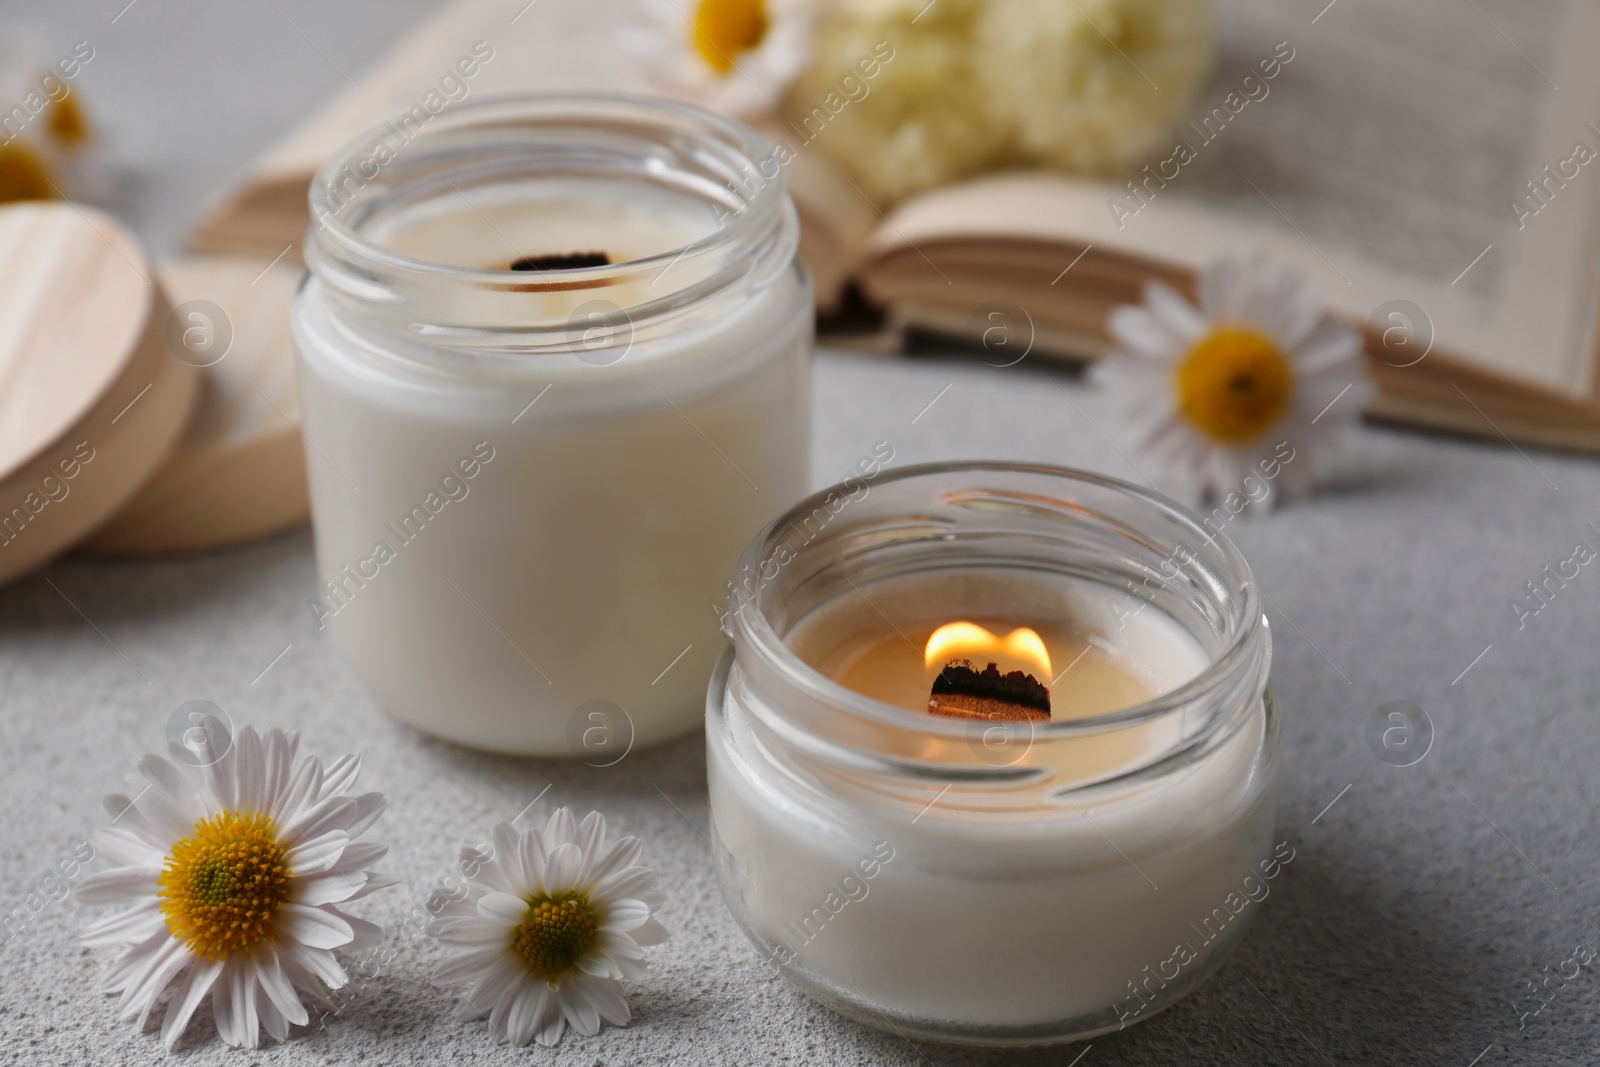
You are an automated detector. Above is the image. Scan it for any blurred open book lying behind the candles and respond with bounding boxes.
[195,0,1600,451]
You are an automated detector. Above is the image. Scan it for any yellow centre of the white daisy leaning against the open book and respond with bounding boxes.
[1173,326,1294,445]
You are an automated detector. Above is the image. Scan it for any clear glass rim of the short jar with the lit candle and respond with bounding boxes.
[725,461,1269,751]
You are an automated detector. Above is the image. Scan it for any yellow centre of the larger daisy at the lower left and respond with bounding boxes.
[157,811,290,960]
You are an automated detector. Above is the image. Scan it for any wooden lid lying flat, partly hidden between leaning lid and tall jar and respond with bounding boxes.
[78,256,310,555]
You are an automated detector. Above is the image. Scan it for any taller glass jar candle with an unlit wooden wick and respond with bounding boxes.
[293,96,811,761]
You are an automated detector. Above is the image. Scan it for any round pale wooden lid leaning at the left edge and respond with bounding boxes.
[0,202,200,581]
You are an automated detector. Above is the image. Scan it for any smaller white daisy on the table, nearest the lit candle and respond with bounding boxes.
[430,808,667,1045]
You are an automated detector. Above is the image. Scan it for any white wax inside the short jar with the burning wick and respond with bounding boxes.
[710,571,1274,1040]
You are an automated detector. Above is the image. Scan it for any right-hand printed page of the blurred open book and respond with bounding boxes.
[869,0,1600,398]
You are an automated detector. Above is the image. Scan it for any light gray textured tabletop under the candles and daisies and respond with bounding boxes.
[0,0,1600,1067]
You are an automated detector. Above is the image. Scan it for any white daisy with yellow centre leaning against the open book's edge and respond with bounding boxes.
[1094,259,1370,507]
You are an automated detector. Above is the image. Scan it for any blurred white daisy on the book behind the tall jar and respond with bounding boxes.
[624,0,811,120]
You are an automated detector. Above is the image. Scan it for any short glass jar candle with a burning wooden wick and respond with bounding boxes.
[707,464,1293,1045]
